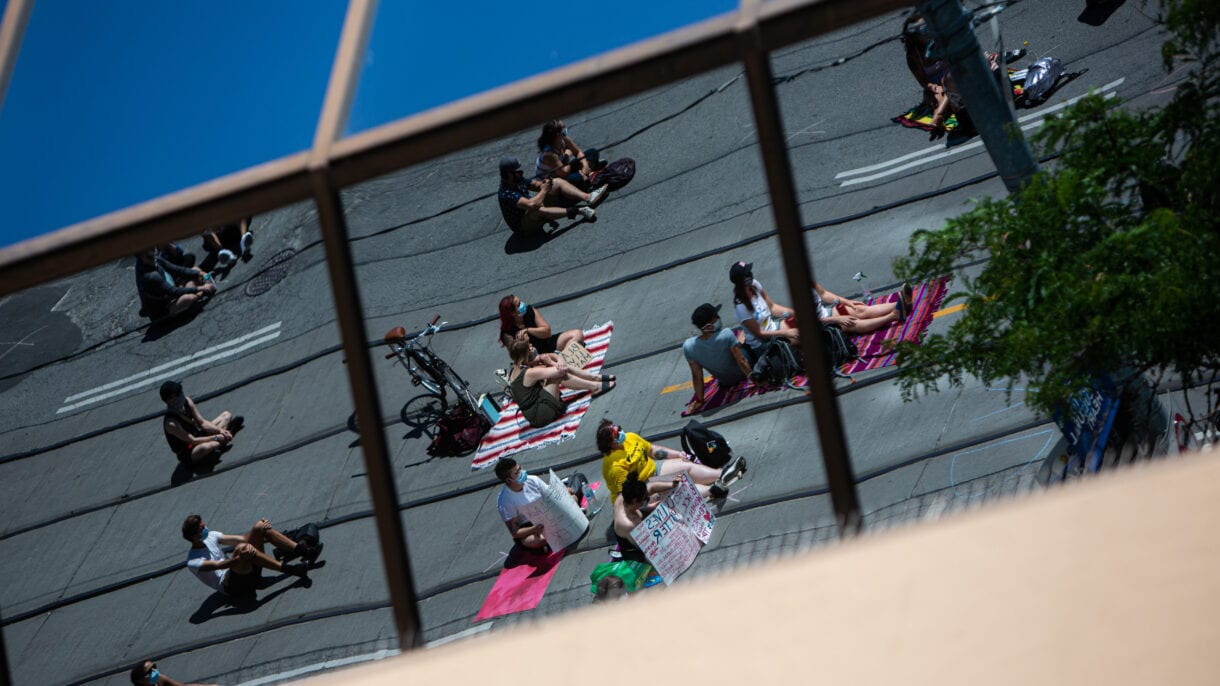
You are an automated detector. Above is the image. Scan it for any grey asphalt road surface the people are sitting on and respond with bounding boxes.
[0,0,1172,684]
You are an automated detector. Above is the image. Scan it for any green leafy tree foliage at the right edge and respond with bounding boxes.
[894,0,1220,411]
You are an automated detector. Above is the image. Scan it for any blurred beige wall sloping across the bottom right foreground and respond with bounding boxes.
[305,454,1220,686]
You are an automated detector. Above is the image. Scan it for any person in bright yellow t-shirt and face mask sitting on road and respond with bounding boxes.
[597,419,745,499]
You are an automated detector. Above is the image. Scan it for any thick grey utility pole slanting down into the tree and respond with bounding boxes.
[917,0,1038,193]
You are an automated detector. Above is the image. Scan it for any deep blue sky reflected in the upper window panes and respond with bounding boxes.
[0,0,737,248]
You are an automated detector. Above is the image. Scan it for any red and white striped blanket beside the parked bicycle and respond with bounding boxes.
[471,321,614,470]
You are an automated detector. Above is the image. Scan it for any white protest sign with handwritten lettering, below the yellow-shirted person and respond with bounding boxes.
[631,474,716,586]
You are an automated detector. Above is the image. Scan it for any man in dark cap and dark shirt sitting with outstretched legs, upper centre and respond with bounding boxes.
[499,157,608,236]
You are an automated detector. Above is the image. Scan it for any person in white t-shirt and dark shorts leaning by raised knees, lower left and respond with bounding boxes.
[182,514,320,598]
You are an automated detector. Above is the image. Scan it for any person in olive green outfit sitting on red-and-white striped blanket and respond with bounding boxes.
[509,339,615,426]
